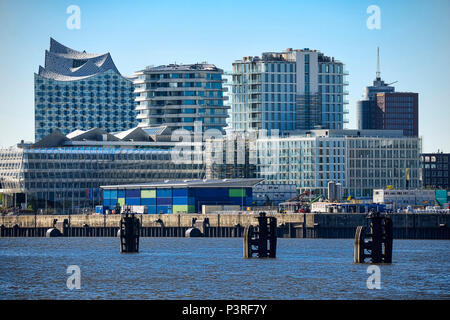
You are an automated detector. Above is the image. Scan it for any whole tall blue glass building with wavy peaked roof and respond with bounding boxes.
[34,38,137,141]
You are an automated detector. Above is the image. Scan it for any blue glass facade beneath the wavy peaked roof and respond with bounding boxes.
[34,70,137,141]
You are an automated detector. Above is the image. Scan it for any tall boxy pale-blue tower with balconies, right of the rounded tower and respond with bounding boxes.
[232,49,348,132]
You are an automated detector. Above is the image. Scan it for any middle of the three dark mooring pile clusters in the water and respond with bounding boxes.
[244,212,277,258]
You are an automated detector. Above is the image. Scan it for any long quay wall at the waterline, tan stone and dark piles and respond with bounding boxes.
[0,213,450,239]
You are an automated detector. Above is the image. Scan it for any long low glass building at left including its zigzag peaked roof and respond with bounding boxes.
[0,127,205,213]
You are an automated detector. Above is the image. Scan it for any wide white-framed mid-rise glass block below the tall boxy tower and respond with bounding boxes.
[256,130,421,198]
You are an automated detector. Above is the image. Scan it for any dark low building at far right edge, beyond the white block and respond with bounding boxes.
[421,152,450,190]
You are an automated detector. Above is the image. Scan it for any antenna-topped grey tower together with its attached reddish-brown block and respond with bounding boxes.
[356,49,419,136]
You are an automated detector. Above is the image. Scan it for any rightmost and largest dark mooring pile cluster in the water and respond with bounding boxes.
[354,212,393,263]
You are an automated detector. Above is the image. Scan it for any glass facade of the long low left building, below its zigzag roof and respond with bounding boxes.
[0,147,204,213]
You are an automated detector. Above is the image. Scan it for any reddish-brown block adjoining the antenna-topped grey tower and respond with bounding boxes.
[377,92,419,136]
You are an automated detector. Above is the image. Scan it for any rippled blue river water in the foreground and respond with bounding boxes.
[0,238,450,299]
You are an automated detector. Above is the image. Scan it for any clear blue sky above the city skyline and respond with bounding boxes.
[0,0,450,152]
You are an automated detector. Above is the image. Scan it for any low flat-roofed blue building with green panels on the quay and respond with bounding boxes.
[98,179,262,214]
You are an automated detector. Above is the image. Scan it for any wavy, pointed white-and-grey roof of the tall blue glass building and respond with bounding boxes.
[38,38,120,81]
